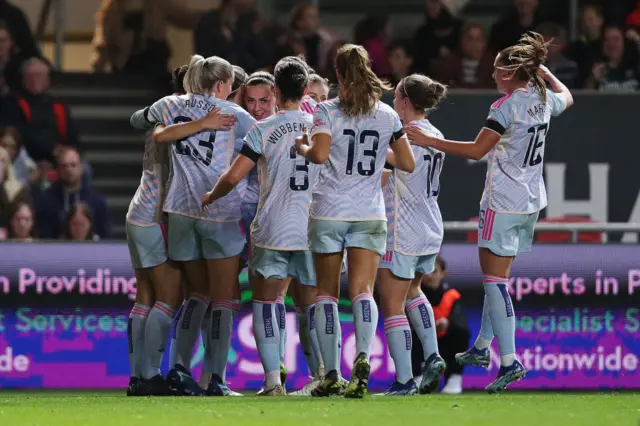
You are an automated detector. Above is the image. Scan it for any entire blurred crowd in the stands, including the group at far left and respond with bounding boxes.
[0,0,640,241]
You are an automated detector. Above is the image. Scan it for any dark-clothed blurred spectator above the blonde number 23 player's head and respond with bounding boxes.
[193,0,268,72]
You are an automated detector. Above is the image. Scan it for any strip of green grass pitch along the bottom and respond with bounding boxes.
[0,391,640,426]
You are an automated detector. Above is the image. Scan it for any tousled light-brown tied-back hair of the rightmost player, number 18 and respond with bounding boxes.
[499,32,548,102]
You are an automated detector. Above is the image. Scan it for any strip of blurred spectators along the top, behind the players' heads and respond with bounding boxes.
[87,0,640,91]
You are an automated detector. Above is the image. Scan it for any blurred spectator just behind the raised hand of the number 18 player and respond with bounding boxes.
[536,22,580,89]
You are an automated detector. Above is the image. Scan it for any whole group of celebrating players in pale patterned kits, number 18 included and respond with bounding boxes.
[126,33,573,398]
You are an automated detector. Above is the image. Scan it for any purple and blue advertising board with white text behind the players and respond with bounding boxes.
[0,243,640,389]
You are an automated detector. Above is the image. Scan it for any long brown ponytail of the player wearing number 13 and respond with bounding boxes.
[336,44,392,117]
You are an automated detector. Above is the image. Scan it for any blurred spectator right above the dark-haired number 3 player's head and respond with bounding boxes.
[291,3,334,69]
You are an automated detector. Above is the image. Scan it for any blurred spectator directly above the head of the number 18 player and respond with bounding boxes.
[489,0,540,53]
